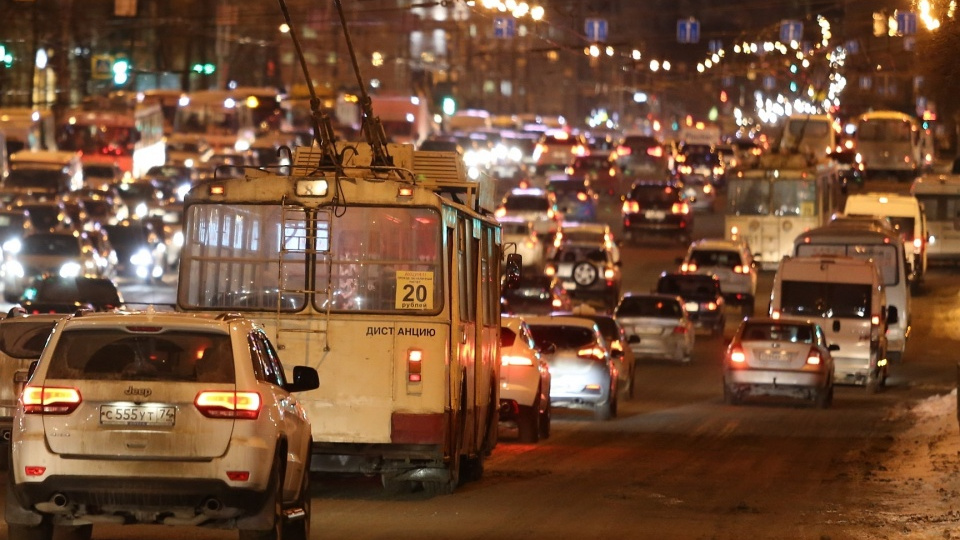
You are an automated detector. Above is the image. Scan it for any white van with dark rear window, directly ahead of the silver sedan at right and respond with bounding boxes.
[770,255,898,393]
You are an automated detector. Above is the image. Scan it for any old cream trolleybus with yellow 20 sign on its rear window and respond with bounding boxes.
[177,143,519,493]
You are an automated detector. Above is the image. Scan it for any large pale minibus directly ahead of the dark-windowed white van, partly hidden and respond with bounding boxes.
[794,220,910,360]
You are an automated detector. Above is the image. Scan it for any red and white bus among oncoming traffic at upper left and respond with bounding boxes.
[57,103,167,179]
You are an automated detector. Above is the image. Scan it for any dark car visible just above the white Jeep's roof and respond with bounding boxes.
[20,276,123,313]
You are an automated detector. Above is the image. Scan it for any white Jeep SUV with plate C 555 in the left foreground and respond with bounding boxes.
[6,309,319,540]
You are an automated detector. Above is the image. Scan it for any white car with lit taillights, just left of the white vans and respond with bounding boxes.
[680,238,757,316]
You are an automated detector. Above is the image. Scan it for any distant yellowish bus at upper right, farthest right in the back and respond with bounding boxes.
[856,111,925,181]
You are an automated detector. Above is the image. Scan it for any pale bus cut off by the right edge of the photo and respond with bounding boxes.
[910,174,960,264]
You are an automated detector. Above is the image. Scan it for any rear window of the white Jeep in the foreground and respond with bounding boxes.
[47,329,235,383]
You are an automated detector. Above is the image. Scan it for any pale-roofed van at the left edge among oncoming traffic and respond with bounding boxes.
[3,150,83,195]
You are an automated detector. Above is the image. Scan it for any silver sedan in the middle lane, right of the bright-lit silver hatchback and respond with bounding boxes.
[614,293,696,362]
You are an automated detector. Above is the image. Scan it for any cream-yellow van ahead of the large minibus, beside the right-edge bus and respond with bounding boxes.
[843,192,929,290]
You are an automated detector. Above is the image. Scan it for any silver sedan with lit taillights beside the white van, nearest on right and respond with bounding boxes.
[723,317,839,409]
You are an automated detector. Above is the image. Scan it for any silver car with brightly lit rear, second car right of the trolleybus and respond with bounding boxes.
[526,315,619,420]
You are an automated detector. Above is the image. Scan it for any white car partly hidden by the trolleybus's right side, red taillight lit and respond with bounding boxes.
[500,316,550,443]
